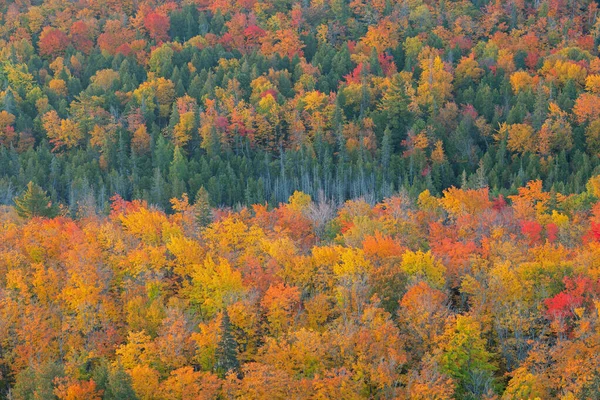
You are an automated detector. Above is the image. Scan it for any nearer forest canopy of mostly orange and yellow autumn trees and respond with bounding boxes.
[0,181,600,400]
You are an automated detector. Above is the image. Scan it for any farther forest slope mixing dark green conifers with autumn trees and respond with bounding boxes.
[0,0,600,209]
